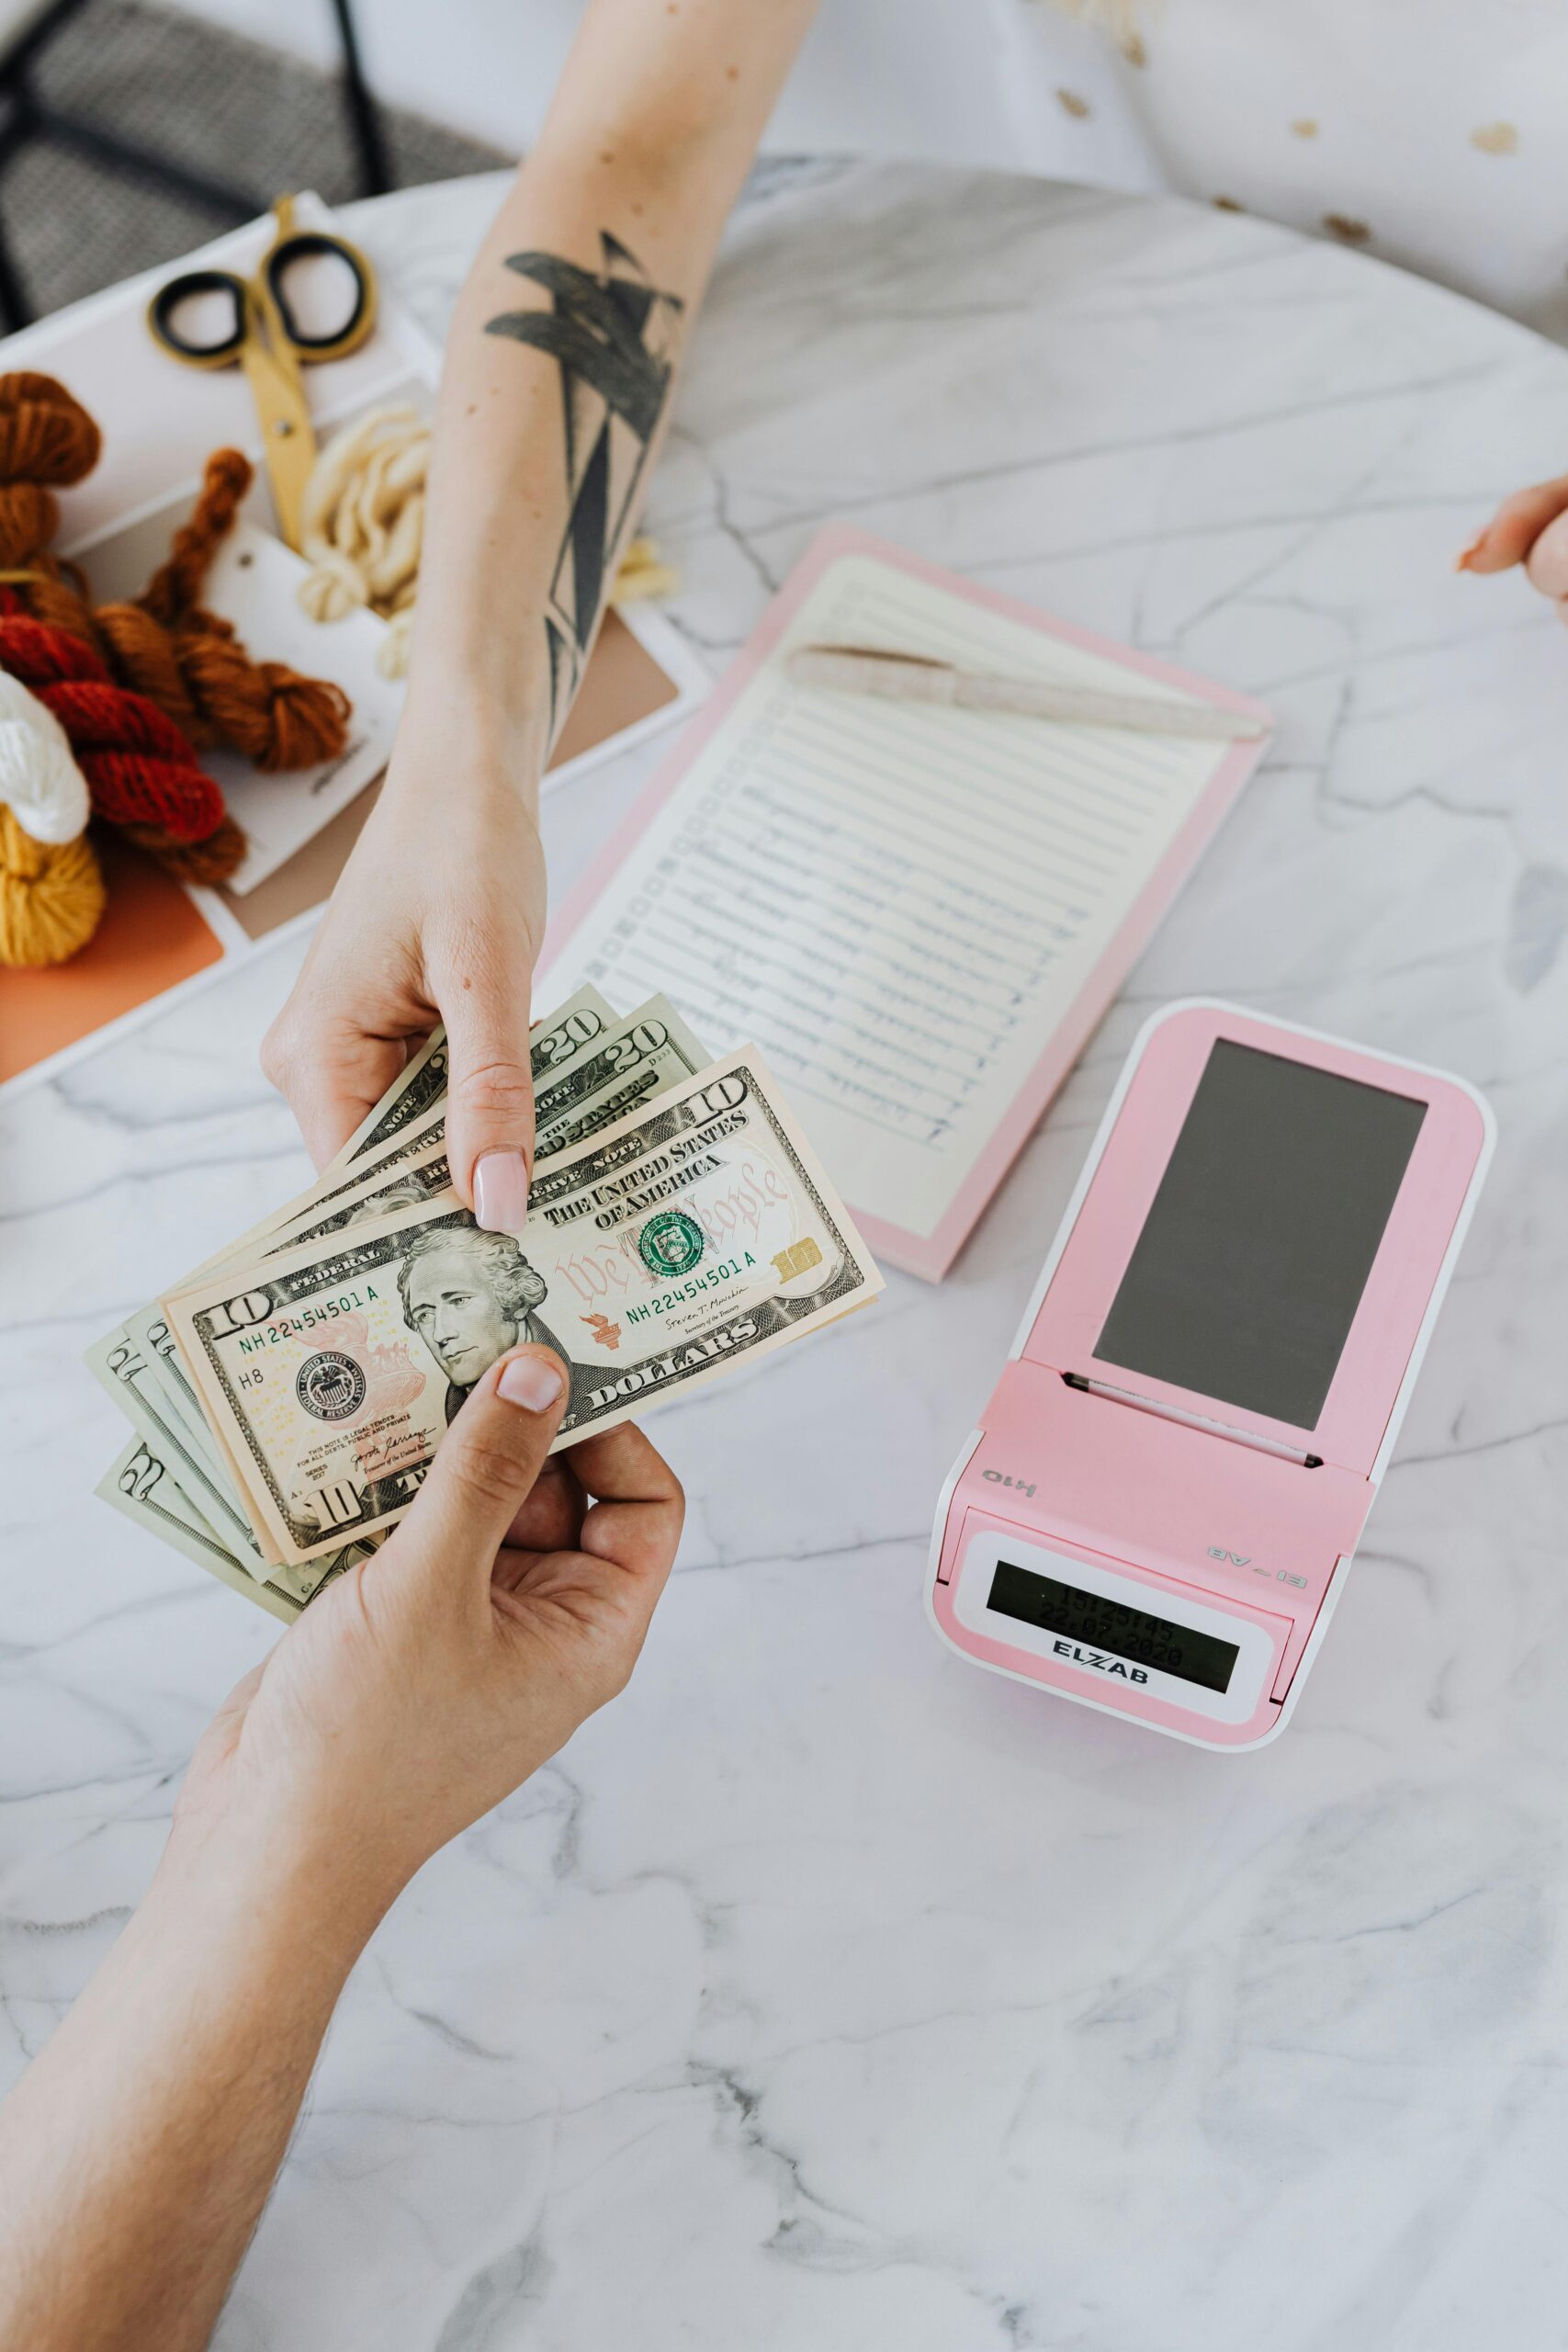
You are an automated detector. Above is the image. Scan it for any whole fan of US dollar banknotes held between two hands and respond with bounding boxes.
[87,988,882,1621]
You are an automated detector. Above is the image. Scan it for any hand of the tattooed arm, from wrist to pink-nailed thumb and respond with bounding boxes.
[261,703,546,1232]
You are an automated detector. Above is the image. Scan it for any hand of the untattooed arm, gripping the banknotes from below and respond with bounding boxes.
[169,1348,684,1945]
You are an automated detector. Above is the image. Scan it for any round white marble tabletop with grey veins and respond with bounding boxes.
[0,167,1568,2352]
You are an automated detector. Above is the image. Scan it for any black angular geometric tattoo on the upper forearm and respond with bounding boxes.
[484,231,684,734]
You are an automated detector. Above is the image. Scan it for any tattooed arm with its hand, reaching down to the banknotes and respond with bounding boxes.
[264,0,816,1227]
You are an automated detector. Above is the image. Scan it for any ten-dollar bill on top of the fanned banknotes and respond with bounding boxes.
[167,1049,882,1562]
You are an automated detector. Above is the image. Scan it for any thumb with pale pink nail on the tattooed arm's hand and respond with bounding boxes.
[442,974,534,1232]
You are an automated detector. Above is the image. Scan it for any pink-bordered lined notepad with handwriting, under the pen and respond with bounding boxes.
[538,526,1267,1280]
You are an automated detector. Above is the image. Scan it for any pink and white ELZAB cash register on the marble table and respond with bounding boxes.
[926,1002,1495,1747]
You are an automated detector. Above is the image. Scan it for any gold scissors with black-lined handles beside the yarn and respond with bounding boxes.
[148,195,376,550]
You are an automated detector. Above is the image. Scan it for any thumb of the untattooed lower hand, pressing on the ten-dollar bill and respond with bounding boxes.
[388,1348,567,1590]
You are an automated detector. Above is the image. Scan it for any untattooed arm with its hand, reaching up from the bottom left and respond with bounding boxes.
[0,1348,682,2352]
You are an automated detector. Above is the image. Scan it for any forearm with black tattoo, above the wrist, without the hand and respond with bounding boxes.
[400,0,813,797]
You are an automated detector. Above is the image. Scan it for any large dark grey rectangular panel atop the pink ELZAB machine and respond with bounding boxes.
[1096,1040,1427,1430]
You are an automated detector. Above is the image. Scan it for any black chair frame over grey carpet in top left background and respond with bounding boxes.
[0,0,392,332]
